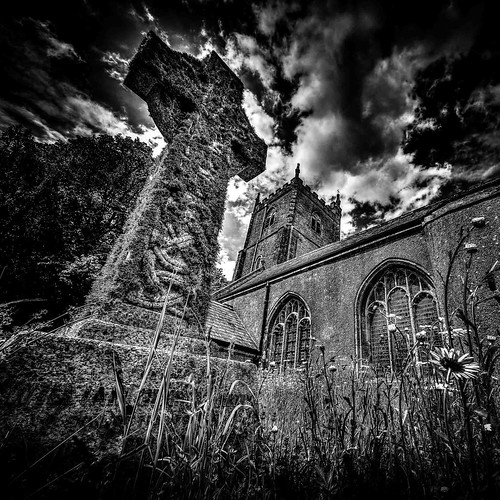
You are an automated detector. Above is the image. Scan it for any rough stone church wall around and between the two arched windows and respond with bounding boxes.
[229,229,431,360]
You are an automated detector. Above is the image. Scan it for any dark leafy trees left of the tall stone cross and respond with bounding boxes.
[0,128,152,332]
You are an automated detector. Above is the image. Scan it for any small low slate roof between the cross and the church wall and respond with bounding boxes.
[207,300,259,350]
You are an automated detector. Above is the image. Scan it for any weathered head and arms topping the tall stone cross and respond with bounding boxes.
[124,32,267,181]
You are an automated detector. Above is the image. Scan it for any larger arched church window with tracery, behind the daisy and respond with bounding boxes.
[361,266,442,373]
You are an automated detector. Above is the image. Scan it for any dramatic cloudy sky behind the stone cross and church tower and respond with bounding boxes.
[0,0,500,278]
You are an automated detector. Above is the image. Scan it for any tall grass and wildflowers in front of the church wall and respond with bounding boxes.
[111,248,500,499]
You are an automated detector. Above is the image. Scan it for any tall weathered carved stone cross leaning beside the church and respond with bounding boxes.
[90,32,267,332]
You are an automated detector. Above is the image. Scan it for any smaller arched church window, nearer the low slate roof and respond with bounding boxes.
[267,296,312,368]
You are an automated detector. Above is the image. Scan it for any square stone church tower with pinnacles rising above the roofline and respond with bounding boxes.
[233,164,342,280]
